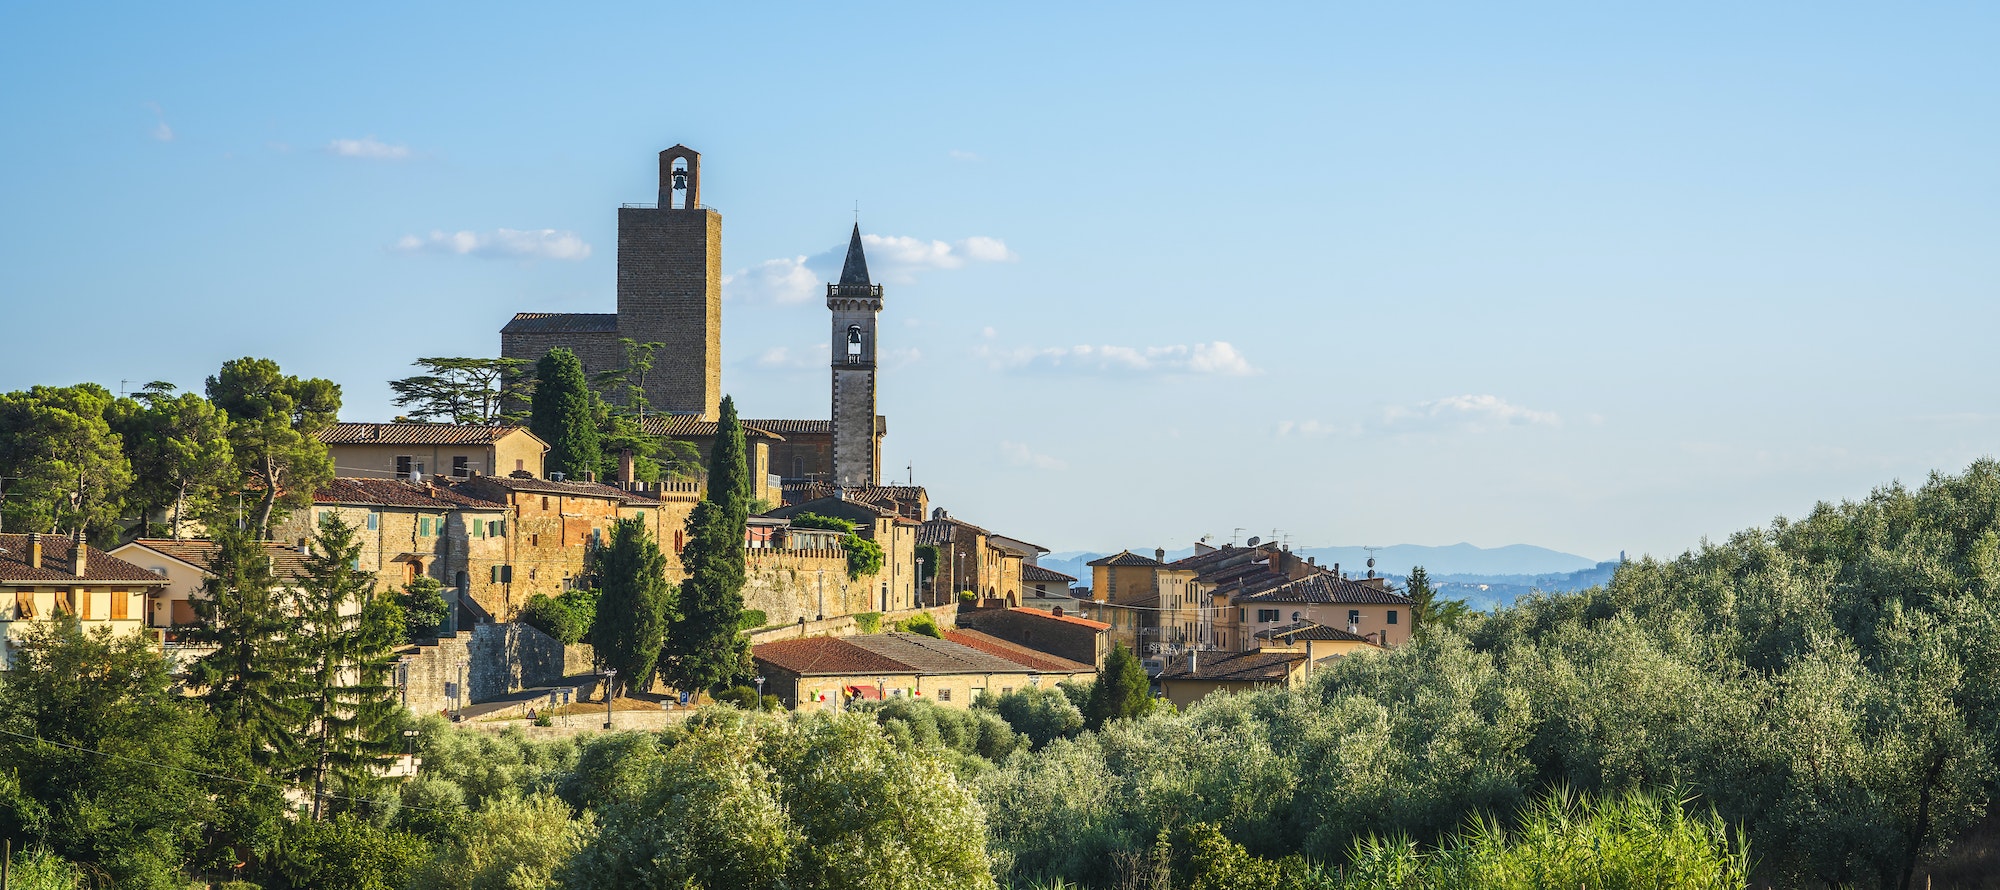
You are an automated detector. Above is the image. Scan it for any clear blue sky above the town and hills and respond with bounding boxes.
[0,4,2000,558]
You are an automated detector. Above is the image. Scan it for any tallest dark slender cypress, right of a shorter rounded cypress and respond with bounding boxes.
[660,396,752,690]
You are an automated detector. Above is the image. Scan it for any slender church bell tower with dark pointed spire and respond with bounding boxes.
[826,222,882,486]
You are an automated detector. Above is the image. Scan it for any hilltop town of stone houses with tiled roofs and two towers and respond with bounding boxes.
[0,146,1418,720]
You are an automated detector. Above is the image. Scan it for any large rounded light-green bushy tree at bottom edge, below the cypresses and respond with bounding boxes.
[566,710,992,890]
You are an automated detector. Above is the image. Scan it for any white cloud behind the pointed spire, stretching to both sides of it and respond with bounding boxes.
[722,234,1020,306]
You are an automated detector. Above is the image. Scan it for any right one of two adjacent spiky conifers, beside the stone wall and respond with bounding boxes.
[298,516,404,818]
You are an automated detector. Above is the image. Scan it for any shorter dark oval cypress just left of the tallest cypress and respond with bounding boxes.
[590,520,674,694]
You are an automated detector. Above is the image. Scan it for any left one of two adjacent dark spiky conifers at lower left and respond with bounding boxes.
[188,522,306,776]
